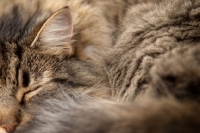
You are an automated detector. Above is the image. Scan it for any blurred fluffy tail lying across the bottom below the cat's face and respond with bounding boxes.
[17,97,200,133]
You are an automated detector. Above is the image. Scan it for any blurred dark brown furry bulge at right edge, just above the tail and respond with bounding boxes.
[150,46,200,101]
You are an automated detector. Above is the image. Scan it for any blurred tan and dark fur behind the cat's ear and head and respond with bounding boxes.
[0,0,113,60]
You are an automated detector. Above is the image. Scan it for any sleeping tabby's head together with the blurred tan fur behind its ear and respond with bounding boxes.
[0,0,123,133]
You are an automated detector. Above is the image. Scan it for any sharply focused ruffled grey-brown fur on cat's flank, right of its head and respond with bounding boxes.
[105,0,200,101]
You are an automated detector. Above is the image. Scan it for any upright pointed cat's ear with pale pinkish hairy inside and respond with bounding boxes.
[31,7,74,55]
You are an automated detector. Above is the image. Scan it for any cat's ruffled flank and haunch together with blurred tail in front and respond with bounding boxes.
[14,0,200,133]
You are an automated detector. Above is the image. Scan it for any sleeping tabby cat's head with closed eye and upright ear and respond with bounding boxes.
[0,7,101,132]
